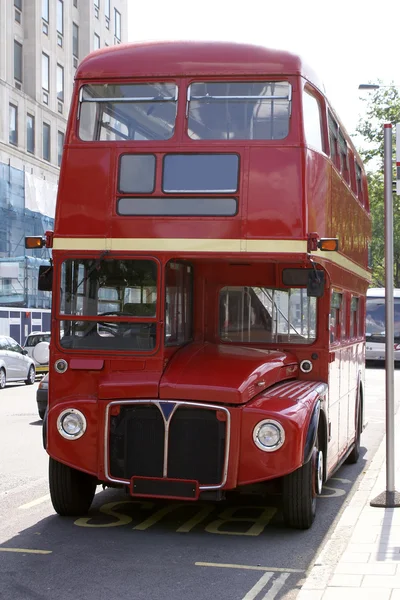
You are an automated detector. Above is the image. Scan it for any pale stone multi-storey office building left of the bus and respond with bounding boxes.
[0,0,128,308]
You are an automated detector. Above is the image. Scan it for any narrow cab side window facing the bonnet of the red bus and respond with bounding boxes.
[165,261,193,346]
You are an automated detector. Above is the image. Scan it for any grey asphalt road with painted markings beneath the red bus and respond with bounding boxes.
[0,369,400,600]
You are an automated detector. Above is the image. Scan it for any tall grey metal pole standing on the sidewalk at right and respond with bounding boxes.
[371,123,400,508]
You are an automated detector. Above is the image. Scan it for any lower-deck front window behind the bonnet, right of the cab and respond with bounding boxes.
[219,287,316,344]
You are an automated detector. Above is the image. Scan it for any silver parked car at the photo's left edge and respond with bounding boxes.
[0,335,36,389]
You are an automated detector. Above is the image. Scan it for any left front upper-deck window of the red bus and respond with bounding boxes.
[78,83,178,141]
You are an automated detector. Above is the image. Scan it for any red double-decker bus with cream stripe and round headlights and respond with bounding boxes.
[27,42,370,528]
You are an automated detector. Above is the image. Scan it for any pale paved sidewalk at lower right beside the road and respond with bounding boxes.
[297,410,400,600]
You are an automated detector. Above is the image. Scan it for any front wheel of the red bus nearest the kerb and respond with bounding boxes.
[282,446,324,529]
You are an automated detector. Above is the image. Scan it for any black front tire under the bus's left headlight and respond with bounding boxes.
[49,457,97,517]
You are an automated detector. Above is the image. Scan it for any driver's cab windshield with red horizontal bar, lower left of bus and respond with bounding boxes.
[59,259,157,350]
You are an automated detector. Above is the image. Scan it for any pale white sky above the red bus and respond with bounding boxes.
[128,0,400,145]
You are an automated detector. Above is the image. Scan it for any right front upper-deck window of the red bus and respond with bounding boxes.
[188,81,292,140]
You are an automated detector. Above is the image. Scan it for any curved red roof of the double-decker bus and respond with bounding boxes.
[76,41,324,91]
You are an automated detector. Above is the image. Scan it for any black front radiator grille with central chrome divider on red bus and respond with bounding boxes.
[108,403,227,485]
